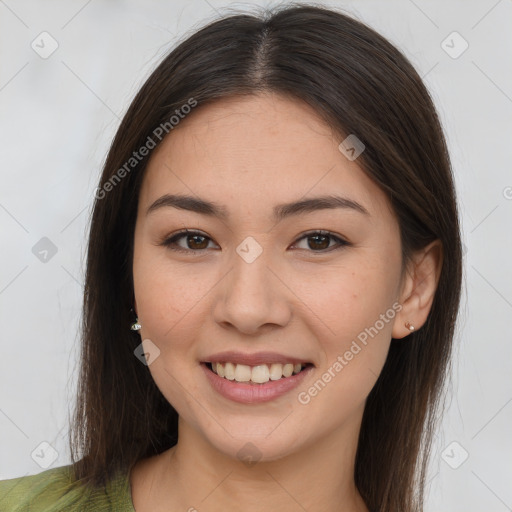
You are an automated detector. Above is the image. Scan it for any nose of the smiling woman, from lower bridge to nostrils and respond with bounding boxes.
[213,251,292,335]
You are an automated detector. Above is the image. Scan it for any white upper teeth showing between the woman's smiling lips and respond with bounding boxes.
[204,362,313,384]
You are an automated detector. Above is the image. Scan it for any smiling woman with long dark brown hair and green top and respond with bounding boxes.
[0,6,461,512]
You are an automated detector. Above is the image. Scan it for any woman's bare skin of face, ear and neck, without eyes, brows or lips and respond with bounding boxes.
[130,93,442,512]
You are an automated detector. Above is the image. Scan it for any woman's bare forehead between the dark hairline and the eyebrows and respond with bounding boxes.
[141,93,392,222]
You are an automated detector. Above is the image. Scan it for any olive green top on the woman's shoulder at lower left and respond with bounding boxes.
[0,464,135,512]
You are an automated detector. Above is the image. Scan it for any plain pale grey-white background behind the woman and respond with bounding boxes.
[0,0,512,512]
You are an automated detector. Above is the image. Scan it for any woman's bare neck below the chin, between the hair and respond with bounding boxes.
[143,408,368,512]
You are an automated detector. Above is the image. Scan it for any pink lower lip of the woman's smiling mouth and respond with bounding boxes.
[201,363,313,404]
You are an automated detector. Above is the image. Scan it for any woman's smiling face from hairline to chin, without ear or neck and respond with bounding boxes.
[133,94,401,460]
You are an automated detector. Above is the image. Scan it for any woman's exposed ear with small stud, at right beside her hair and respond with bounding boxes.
[392,240,443,339]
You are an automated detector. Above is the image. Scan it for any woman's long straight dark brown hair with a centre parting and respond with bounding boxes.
[70,5,462,512]
